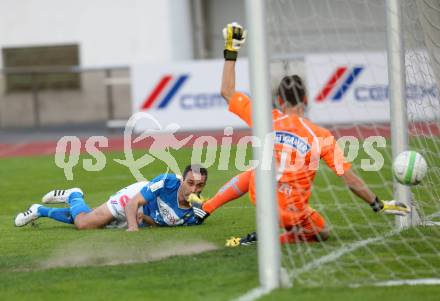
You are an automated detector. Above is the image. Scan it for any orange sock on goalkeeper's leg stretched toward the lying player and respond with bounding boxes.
[202,170,252,213]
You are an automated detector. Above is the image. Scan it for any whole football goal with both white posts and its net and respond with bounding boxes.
[245,0,440,292]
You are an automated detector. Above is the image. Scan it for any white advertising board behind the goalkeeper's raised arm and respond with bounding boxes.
[131,59,249,130]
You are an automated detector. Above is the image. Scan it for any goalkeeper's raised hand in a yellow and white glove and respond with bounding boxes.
[223,22,247,61]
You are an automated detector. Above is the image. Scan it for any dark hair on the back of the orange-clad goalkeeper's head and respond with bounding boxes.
[278,74,306,106]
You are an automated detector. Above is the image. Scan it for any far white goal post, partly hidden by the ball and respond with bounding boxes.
[386,0,419,228]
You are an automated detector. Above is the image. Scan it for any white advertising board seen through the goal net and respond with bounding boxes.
[306,52,439,124]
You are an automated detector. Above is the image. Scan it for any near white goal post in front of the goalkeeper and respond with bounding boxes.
[246,0,281,291]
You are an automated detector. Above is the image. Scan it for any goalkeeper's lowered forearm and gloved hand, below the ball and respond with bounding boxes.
[341,170,411,216]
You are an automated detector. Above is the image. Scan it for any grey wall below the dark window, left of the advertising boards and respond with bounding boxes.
[0,68,131,128]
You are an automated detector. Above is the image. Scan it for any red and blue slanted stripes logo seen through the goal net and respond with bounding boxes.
[315,66,364,102]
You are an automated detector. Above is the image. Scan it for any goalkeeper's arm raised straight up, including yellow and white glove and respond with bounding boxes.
[220,22,246,103]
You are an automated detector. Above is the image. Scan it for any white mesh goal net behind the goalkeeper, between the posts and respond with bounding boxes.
[267,0,440,286]
